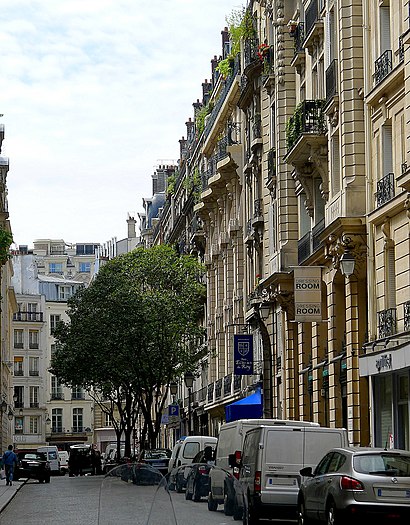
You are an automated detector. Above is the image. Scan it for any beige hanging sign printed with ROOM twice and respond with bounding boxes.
[293,266,323,323]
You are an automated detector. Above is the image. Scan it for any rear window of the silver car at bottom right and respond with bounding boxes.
[353,452,410,477]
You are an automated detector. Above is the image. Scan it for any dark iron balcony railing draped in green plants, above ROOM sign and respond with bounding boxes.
[286,100,326,152]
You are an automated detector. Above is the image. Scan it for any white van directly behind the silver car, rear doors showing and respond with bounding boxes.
[237,422,349,523]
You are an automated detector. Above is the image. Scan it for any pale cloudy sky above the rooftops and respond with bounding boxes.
[0,0,244,246]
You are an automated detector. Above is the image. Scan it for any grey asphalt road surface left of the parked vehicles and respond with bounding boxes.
[0,476,241,525]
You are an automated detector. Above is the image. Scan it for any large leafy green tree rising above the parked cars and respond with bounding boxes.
[51,245,205,455]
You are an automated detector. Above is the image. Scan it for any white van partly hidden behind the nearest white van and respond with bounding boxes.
[208,419,319,519]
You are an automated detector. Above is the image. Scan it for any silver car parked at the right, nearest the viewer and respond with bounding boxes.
[298,448,410,525]
